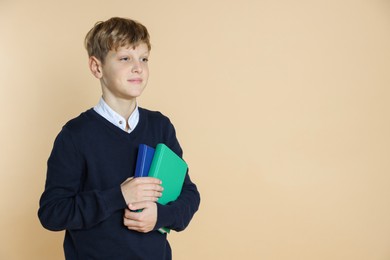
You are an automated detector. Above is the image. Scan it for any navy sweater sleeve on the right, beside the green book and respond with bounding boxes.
[154,122,200,231]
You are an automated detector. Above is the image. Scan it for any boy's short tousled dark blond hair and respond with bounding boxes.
[84,17,151,62]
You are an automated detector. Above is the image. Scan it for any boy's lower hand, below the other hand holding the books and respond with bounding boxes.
[123,201,157,233]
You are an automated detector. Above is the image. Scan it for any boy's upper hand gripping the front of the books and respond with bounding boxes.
[121,177,163,205]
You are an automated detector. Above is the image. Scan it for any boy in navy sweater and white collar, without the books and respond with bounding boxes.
[38,18,200,260]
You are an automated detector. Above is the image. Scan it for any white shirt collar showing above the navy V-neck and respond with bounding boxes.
[93,97,139,133]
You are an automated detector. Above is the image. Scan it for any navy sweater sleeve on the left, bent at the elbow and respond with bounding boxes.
[38,127,126,231]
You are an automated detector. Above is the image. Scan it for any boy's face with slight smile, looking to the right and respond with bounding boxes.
[95,43,149,100]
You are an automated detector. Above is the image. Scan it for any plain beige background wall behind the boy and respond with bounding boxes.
[0,0,390,260]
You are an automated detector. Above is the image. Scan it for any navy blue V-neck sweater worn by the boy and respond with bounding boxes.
[38,108,200,260]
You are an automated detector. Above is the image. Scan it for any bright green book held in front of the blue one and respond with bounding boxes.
[148,144,188,233]
